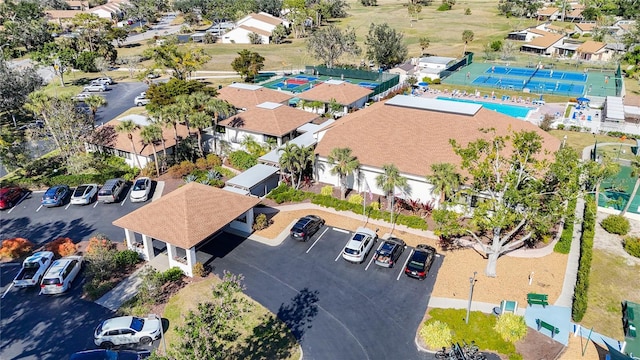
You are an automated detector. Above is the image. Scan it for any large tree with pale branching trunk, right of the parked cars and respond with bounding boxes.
[450,129,581,277]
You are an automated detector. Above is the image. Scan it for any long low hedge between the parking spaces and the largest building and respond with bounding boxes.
[267,184,427,230]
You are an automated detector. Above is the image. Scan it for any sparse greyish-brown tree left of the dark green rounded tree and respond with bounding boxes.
[307,25,362,68]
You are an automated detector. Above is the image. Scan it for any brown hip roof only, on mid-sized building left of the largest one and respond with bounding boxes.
[219,105,319,137]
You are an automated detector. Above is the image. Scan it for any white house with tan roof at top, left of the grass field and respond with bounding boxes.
[222,12,289,44]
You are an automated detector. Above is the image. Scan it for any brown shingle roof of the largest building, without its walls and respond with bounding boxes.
[316,98,560,176]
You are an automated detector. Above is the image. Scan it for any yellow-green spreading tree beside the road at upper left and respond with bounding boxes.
[144,41,211,80]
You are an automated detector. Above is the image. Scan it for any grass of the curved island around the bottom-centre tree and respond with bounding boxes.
[162,276,302,360]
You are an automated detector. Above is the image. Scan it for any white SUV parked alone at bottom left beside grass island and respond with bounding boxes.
[93,314,162,349]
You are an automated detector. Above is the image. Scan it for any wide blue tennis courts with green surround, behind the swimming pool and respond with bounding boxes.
[442,63,616,97]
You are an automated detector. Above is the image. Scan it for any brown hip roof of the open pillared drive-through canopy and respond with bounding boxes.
[113,181,260,249]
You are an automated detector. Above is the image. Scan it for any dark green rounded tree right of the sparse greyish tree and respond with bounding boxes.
[364,23,408,66]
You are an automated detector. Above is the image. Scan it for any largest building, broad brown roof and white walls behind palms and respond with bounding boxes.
[314,95,560,203]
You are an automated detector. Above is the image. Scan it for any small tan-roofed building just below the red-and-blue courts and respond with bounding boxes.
[298,80,373,116]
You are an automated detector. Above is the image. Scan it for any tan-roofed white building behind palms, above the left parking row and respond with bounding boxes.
[86,115,188,168]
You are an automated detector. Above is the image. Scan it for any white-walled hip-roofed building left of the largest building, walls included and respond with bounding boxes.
[216,102,320,150]
